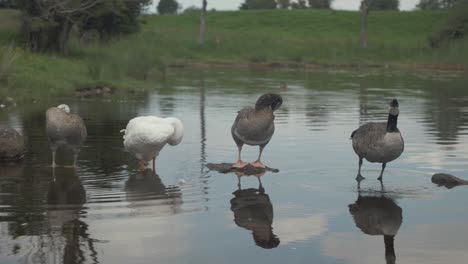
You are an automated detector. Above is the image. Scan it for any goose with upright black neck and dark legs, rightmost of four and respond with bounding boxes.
[351,99,405,181]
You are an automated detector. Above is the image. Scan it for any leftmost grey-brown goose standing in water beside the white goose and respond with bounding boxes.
[46,104,88,168]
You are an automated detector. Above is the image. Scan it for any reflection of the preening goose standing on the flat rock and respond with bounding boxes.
[231,176,280,249]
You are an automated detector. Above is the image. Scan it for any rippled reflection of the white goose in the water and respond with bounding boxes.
[125,168,183,215]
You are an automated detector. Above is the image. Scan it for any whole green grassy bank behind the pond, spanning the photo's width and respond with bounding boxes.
[0,10,468,97]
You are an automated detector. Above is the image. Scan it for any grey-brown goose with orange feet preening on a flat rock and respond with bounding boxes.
[231,93,283,168]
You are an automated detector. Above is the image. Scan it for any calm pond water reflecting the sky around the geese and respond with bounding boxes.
[0,69,468,263]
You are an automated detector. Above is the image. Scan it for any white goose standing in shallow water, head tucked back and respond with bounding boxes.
[120,116,184,173]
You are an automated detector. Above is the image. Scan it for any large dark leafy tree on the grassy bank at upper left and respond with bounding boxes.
[18,0,149,54]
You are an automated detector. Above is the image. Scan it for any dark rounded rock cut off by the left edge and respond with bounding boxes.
[0,126,24,161]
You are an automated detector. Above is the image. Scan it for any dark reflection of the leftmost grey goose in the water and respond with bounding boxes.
[47,169,99,263]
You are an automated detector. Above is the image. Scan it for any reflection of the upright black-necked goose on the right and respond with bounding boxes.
[349,187,403,264]
